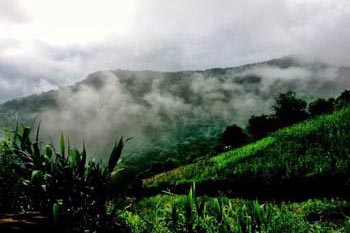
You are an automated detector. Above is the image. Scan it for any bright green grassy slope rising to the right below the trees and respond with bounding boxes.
[143,109,350,195]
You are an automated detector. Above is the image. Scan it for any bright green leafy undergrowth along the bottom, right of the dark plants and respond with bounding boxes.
[119,186,350,233]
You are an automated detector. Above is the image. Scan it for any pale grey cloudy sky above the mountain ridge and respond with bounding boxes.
[0,0,350,102]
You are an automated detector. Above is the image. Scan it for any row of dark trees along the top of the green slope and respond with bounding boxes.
[218,90,350,151]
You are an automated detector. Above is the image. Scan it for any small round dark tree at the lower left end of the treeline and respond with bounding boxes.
[221,125,248,148]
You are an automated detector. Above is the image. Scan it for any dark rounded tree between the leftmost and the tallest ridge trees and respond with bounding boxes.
[247,115,277,139]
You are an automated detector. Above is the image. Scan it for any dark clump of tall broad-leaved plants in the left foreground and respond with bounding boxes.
[0,126,130,232]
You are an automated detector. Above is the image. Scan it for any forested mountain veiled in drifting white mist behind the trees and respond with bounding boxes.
[0,56,350,157]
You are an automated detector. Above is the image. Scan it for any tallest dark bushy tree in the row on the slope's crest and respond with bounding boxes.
[272,91,308,127]
